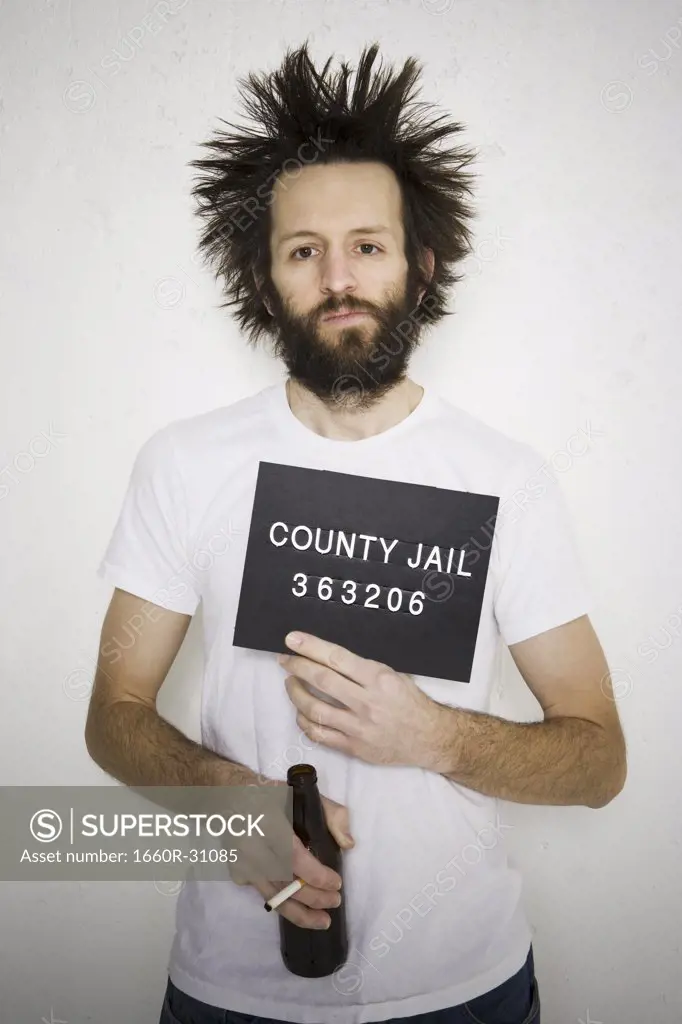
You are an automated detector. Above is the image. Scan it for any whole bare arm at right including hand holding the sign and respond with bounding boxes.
[278,614,627,808]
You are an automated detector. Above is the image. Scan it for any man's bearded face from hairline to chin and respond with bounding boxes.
[265,163,430,407]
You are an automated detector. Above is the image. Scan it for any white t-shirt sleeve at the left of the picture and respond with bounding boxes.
[97,427,200,615]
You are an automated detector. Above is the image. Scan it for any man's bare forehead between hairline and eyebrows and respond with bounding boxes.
[271,163,402,245]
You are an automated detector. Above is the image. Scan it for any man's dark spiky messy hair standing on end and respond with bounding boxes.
[189,42,475,345]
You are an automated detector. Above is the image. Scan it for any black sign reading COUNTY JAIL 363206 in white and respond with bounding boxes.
[233,462,500,683]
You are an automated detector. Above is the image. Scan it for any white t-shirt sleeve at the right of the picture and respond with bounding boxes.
[492,446,594,646]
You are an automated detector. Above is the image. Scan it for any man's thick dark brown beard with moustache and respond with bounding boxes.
[267,260,423,410]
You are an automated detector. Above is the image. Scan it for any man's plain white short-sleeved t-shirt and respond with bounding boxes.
[98,381,592,1024]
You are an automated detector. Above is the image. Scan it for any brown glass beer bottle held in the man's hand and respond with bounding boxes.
[280,764,348,978]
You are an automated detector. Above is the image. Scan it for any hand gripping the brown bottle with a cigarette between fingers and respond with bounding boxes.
[238,797,353,928]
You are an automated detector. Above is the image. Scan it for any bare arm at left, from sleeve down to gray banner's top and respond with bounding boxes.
[85,588,262,786]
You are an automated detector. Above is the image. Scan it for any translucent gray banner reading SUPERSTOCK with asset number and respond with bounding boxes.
[0,784,294,884]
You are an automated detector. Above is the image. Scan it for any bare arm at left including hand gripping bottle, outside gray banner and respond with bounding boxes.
[85,588,348,928]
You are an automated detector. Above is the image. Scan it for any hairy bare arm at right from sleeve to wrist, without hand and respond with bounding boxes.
[422,615,627,808]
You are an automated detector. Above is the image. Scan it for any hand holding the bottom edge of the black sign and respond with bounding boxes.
[278,634,440,768]
